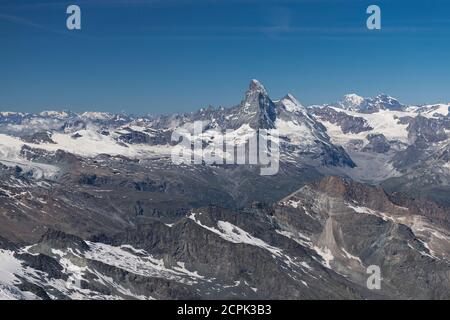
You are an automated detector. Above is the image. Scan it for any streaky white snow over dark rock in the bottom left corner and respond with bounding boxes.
[0,242,217,300]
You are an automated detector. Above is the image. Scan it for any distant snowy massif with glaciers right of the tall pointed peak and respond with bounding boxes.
[311,95,450,203]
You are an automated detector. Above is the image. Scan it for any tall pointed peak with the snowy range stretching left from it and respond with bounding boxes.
[0,80,354,176]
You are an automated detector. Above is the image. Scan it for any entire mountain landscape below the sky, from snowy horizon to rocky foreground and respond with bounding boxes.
[0,80,450,299]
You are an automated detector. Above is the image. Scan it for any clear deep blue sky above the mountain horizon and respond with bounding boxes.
[0,0,450,114]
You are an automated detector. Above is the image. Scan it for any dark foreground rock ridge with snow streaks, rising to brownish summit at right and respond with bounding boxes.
[0,177,450,299]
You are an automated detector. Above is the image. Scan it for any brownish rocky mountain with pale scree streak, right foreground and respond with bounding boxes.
[274,178,450,299]
